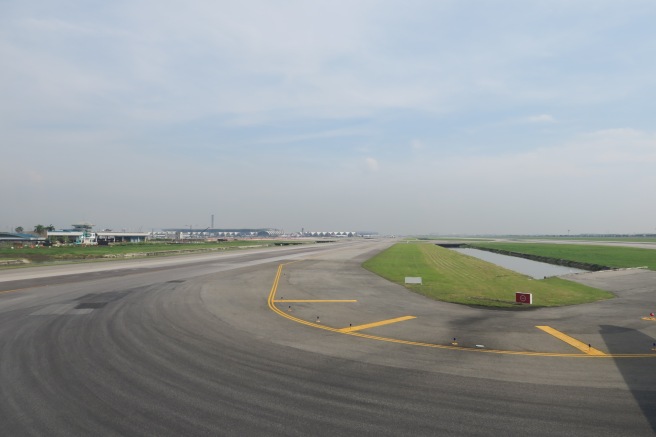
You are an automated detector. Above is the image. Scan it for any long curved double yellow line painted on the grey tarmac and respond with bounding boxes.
[267,260,656,359]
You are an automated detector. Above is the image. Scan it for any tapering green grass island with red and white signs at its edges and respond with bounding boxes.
[363,243,613,308]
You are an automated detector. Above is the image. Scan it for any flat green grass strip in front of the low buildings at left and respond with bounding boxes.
[0,240,294,263]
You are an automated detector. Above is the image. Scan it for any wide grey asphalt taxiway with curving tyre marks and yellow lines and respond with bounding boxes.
[0,240,656,436]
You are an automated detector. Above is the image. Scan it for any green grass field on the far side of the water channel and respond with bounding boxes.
[470,242,656,270]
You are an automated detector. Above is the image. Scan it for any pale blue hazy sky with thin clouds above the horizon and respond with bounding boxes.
[0,0,656,235]
